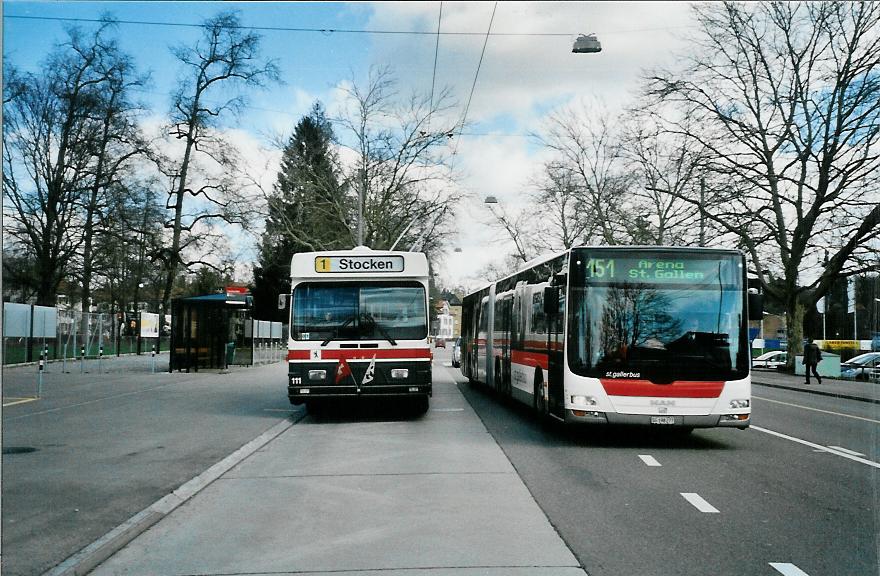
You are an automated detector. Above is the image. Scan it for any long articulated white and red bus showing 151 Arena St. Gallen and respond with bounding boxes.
[461,247,762,431]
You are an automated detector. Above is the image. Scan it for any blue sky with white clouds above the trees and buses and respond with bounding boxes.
[2,0,693,289]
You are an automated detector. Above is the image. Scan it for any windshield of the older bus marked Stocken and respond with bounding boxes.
[290,282,428,344]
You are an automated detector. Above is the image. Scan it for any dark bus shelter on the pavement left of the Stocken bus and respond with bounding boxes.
[169,292,253,372]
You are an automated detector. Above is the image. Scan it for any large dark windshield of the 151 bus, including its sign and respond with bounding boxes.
[568,249,749,383]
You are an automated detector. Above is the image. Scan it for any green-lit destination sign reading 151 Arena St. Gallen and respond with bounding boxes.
[584,257,740,284]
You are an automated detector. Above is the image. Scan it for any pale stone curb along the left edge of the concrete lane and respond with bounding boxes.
[43,412,307,576]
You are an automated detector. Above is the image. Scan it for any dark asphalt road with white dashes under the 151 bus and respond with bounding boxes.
[449,360,880,576]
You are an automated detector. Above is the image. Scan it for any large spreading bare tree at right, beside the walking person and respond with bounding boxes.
[648,2,880,358]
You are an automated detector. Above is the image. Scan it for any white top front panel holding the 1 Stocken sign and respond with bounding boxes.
[290,246,428,281]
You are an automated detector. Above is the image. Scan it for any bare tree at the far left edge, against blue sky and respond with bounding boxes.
[3,22,118,306]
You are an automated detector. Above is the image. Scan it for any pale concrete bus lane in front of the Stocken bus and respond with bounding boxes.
[94,354,584,576]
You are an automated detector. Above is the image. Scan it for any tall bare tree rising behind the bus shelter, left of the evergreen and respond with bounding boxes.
[158,12,278,309]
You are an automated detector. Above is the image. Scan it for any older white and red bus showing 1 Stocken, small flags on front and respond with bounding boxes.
[287,247,431,412]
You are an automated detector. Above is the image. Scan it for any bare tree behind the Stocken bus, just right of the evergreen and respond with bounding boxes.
[340,68,459,252]
